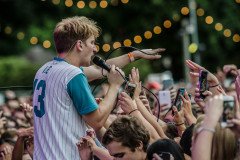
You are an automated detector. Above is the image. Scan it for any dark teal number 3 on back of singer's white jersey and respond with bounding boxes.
[34,79,46,118]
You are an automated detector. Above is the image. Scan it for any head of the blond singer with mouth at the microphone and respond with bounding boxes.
[54,16,100,66]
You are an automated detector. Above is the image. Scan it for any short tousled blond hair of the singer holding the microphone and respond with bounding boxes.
[53,16,101,53]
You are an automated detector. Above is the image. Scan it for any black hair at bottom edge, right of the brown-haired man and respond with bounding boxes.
[147,139,184,160]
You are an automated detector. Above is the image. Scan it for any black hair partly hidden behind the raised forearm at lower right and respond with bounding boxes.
[180,124,195,156]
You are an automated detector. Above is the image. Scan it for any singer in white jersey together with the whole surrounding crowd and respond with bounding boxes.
[0,17,240,160]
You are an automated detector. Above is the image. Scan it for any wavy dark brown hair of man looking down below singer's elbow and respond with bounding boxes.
[102,116,150,152]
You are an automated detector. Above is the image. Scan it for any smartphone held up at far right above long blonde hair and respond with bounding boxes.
[220,96,235,128]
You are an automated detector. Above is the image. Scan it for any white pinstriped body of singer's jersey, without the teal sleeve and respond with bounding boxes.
[33,58,96,160]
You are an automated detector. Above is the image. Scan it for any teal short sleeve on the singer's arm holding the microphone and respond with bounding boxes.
[67,74,98,115]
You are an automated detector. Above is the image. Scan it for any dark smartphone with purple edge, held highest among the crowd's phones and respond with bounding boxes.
[198,70,208,99]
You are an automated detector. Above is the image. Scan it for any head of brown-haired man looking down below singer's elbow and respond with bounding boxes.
[102,116,150,160]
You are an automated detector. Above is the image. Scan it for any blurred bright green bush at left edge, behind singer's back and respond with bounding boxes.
[0,57,39,87]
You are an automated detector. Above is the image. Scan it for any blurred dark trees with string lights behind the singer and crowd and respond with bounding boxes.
[0,0,240,86]
